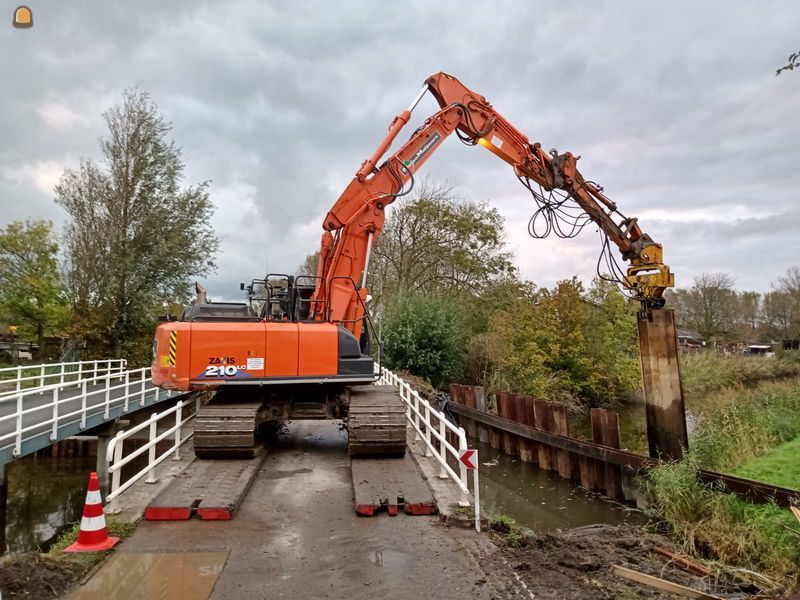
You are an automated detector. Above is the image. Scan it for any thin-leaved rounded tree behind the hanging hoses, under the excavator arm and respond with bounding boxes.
[370,180,513,308]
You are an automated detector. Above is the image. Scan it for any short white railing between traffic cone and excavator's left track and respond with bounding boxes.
[106,396,200,514]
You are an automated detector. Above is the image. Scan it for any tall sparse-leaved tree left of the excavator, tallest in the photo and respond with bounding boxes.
[55,88,219,359]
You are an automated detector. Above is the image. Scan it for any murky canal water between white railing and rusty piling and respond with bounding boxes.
[473,442,645,531]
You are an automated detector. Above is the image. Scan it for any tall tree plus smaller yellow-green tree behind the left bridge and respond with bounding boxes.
[0,88,219,364]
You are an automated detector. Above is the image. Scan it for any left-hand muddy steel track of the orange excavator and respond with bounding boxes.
[193,399,268,458]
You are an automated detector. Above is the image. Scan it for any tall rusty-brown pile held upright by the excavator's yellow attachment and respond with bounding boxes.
[637,309,688,460]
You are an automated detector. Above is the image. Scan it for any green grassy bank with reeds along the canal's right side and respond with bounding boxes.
[646,376,800,585]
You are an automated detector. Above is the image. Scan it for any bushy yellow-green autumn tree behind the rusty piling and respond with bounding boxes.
[481,278,640,404]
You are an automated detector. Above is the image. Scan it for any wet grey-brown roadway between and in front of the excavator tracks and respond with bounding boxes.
[104,421,492,599]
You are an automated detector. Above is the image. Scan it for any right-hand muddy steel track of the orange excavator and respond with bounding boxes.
[347,385,406,458]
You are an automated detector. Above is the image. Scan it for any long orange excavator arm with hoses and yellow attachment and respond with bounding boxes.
[315,73,674,336]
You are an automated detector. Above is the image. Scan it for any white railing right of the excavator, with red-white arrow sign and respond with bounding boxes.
[376,368,481,531]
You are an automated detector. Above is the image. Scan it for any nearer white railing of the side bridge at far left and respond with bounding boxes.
[0,361,158,456]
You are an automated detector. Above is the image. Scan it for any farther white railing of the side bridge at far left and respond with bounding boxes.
[0,358,128,398]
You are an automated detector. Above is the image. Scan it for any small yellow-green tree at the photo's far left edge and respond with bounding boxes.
[0,221,67,348]
